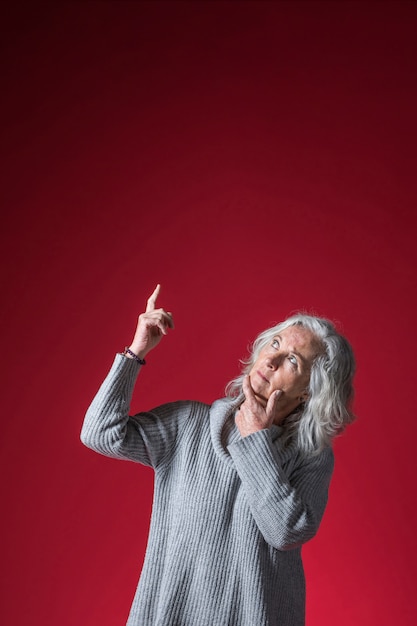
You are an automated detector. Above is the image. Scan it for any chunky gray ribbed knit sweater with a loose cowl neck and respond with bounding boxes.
[81,355,333,626]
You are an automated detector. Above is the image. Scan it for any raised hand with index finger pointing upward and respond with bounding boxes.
[127,285,174,359]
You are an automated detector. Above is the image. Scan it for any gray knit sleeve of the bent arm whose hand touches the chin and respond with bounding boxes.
[228,429,334,550]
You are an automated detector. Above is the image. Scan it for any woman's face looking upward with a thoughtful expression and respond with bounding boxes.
[249,326,320,424]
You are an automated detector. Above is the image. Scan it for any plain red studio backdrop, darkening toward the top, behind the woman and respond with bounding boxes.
[0,2,417,626]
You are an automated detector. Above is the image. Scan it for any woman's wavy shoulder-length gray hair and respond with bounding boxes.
[226,313,355,454]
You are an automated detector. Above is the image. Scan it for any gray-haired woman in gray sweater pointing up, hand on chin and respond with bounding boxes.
[81,285,354,626]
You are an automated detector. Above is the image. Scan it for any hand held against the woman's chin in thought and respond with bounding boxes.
[235,376,282,437]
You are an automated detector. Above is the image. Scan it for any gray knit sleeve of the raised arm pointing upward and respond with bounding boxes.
[81,355,190,467]
